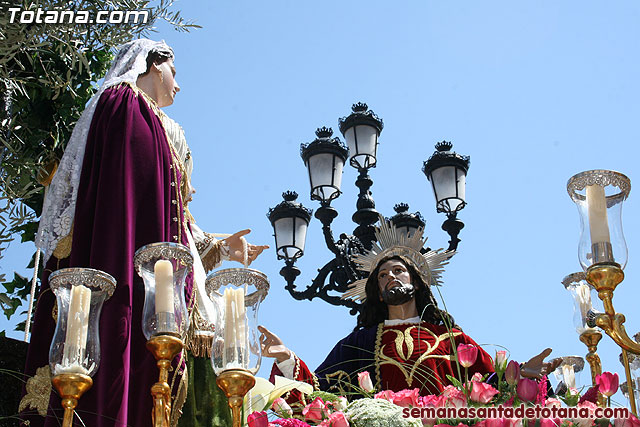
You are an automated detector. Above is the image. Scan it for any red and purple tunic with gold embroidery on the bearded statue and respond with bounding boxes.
[271,322,494,395]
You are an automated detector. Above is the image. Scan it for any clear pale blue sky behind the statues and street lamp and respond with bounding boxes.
[0,0,640,401]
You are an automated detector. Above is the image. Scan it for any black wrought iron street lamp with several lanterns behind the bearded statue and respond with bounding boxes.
[267,103,469,314]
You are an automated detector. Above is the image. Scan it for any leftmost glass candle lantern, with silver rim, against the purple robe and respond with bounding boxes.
[49,268,116,376]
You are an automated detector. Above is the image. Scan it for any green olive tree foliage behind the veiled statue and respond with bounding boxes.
[0,0,198,333]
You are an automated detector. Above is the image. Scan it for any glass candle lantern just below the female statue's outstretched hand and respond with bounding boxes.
[205,268,269,375]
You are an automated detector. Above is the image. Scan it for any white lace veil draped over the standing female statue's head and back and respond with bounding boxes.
[36,39,171,264]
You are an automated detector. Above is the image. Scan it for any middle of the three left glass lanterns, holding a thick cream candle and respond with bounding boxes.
[133,242,193,340]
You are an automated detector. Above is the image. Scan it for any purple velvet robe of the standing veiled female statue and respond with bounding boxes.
[25,85,192,427]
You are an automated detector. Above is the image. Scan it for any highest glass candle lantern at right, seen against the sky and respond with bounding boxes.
[567,170,631,270]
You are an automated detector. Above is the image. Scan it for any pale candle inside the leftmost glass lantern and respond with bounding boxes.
[62,285,91,365]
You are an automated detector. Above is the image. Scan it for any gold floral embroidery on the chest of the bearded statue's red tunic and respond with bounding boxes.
[376,324,462,387]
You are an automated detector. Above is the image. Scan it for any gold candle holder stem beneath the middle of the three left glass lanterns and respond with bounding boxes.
[147,335,184,427]
